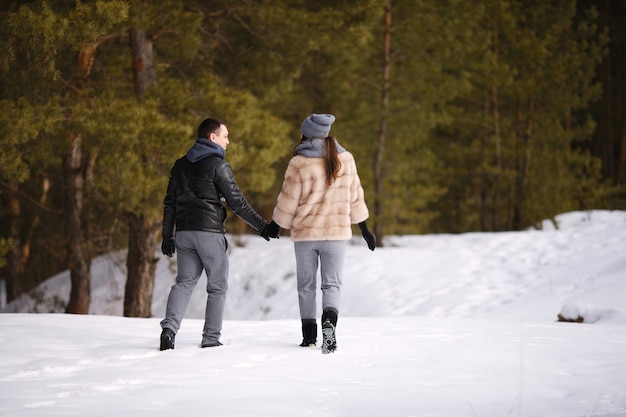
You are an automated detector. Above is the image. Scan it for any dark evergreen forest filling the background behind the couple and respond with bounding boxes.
[0,0,626,317]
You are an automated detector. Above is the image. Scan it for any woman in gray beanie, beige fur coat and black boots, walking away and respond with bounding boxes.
[272,113,376,353]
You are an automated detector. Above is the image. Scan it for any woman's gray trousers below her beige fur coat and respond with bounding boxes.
[294,240,346,319]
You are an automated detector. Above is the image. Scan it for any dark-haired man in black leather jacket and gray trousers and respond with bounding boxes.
[160,119,279,350]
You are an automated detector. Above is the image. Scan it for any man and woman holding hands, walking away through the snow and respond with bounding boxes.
[160,113,376,353]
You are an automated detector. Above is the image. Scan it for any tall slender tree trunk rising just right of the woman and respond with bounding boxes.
[374,1,391,246]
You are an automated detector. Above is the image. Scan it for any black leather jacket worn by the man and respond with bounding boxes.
[163,139,267,238]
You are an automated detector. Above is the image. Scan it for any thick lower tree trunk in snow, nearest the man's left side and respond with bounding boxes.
[124,214,160,317]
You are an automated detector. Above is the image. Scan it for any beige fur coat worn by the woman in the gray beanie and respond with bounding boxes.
[272,151,369,242]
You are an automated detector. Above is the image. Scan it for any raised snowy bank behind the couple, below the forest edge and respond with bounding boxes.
[3,211,626,320]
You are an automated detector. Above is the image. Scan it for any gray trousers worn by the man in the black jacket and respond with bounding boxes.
[161,231,228,344]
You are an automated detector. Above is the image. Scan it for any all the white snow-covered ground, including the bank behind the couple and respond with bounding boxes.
[0,211,626,417]
